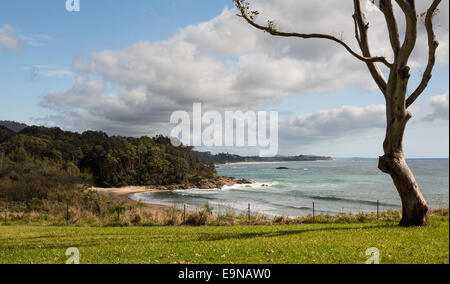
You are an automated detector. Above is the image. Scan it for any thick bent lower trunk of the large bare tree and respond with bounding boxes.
[379,95,428,227]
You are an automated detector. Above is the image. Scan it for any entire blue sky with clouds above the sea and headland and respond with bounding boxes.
[0,0,449,158]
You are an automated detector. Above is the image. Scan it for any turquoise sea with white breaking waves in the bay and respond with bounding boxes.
[132,159,449,217]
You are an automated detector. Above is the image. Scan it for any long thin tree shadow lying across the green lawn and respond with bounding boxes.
[198,224,398,242]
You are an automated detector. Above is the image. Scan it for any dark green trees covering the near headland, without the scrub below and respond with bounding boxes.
[0,126,216,187]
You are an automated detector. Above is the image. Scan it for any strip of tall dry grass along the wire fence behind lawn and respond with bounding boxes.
[0,199,449,227]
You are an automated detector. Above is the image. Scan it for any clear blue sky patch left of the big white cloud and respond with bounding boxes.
[0,0,232,120]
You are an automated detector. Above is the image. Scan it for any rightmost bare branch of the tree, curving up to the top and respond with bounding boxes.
[406,0,442,108]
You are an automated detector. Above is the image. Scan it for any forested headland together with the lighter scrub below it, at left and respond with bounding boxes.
[0,124,218,225]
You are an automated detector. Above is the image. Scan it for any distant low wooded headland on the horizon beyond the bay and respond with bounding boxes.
[194,151,333,164]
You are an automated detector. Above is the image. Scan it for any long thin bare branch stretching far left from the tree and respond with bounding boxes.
[233,0,392,68]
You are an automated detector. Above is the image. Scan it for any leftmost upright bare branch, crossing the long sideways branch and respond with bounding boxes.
[353,0,387,95]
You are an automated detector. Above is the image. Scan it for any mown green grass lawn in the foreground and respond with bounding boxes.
[0,217,449,264]
